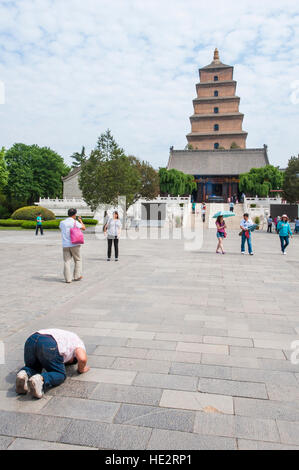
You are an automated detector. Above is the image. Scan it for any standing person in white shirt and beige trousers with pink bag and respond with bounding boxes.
[59,209,86,284]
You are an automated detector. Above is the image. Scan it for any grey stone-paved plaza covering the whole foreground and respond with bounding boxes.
[0,230,299,449]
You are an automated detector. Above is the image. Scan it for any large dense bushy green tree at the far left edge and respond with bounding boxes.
[5,143,70,204]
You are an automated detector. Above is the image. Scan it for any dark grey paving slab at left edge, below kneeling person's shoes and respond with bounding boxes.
[0,411,70,441]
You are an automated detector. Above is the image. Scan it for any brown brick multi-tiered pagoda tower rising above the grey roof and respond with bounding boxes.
[186,49,247,150]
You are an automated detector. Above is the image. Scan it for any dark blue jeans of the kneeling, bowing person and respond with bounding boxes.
[21,333,66,391]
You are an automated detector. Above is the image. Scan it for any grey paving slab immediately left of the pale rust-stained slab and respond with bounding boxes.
[90,384,162,405]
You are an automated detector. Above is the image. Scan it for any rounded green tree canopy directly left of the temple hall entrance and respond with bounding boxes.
[159,168,197,196]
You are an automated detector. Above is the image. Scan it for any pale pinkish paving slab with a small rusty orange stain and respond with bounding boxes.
[160,390,234,414]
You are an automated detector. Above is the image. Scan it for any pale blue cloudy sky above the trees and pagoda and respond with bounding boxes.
[0,0,299,168]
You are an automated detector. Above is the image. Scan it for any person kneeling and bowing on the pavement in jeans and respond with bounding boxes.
[16,329,89,398]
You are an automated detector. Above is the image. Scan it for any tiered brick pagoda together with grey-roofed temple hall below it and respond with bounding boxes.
[167,49,269,202]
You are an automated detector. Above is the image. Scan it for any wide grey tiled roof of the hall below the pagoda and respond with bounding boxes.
[167,146,269,176]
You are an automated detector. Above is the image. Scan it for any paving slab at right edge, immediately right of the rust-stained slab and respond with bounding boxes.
[234,398,299,421]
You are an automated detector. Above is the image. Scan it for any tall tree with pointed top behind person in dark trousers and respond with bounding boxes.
[79,130,141,210]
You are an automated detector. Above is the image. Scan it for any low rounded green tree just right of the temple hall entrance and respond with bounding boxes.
[239,165,283,197]
